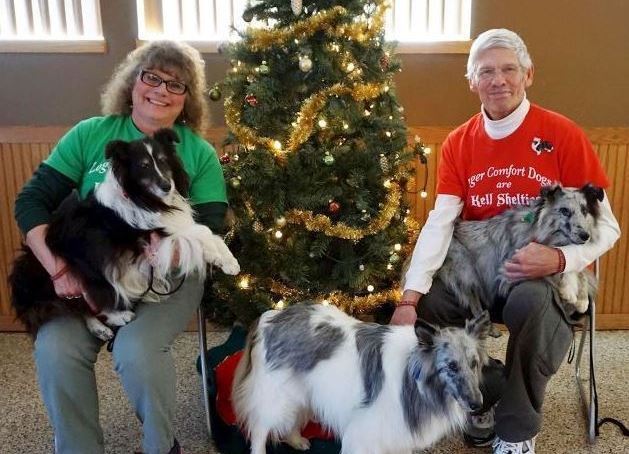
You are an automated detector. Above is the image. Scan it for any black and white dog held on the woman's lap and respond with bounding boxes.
[9,129,240,340]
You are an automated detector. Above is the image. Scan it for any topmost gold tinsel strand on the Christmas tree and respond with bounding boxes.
[245,0,389,52]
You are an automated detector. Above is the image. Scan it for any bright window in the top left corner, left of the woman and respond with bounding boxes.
[0,0,105,52]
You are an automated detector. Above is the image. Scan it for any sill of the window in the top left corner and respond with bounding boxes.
[0,39,107,54]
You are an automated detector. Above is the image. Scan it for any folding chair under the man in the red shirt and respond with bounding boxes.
[575,259,629,443]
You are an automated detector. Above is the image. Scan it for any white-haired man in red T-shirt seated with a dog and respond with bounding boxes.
[391,29,620,454]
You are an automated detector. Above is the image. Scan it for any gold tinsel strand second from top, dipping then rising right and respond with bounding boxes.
[225,83,388,159]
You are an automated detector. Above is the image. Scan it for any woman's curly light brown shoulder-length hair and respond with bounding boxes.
[101,41,209,134]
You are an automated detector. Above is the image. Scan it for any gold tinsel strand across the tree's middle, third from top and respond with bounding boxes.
[286,182,401,240]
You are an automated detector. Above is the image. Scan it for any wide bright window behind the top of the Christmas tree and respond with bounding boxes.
[136,0,472,53]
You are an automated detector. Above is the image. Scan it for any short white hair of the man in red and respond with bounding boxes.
[465,28,533,82]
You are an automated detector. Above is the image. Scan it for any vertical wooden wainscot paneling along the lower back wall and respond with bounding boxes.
[0,127,629,331]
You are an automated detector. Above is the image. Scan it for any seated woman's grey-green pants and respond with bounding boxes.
[34,277,203,454]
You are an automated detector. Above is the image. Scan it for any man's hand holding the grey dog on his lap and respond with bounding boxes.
[504,242,559,281]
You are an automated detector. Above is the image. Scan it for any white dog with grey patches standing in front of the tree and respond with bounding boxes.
[232,304,490,454]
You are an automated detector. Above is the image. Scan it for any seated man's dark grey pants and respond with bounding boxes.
[417,280,572,442]
